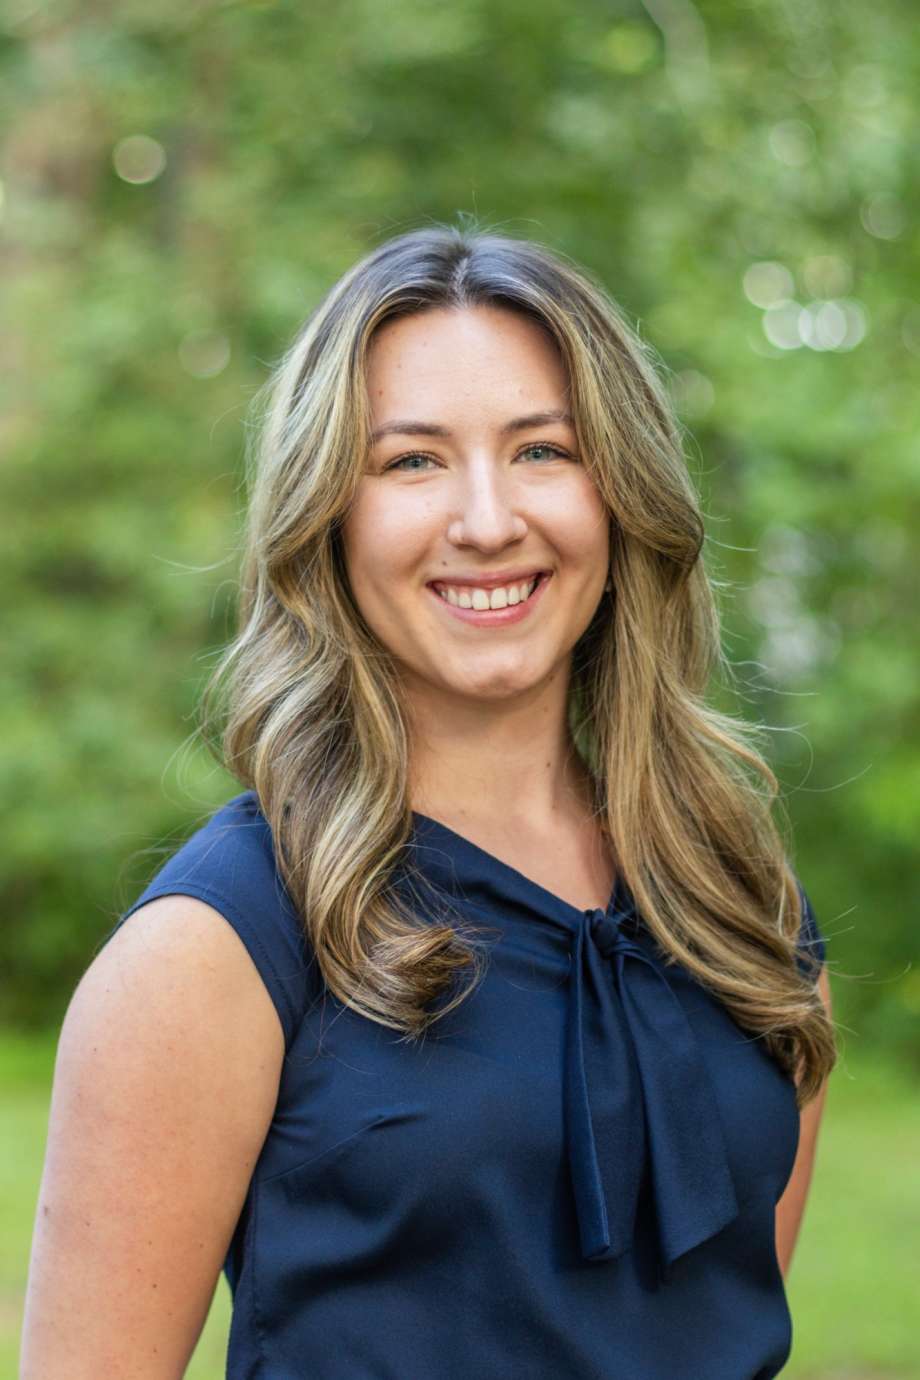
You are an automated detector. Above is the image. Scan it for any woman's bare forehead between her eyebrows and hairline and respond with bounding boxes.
[367,306,568,422]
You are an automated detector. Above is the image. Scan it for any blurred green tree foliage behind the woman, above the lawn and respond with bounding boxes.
[0,0,920,1067]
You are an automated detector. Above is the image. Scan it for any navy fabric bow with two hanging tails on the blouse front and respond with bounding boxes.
[564,891,738,1281]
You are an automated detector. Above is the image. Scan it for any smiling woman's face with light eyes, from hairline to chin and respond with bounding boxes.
[342,306,610,701]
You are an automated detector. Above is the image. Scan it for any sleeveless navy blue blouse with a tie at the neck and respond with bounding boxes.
[103,791,825,1380]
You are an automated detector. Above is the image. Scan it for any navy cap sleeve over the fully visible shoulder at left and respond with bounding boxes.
[97,791,320,1050]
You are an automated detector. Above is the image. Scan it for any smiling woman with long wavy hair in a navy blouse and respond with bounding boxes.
[23,220,834,1380]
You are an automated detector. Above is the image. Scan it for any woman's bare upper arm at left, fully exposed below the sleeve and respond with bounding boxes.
[19,896,284,1380]
